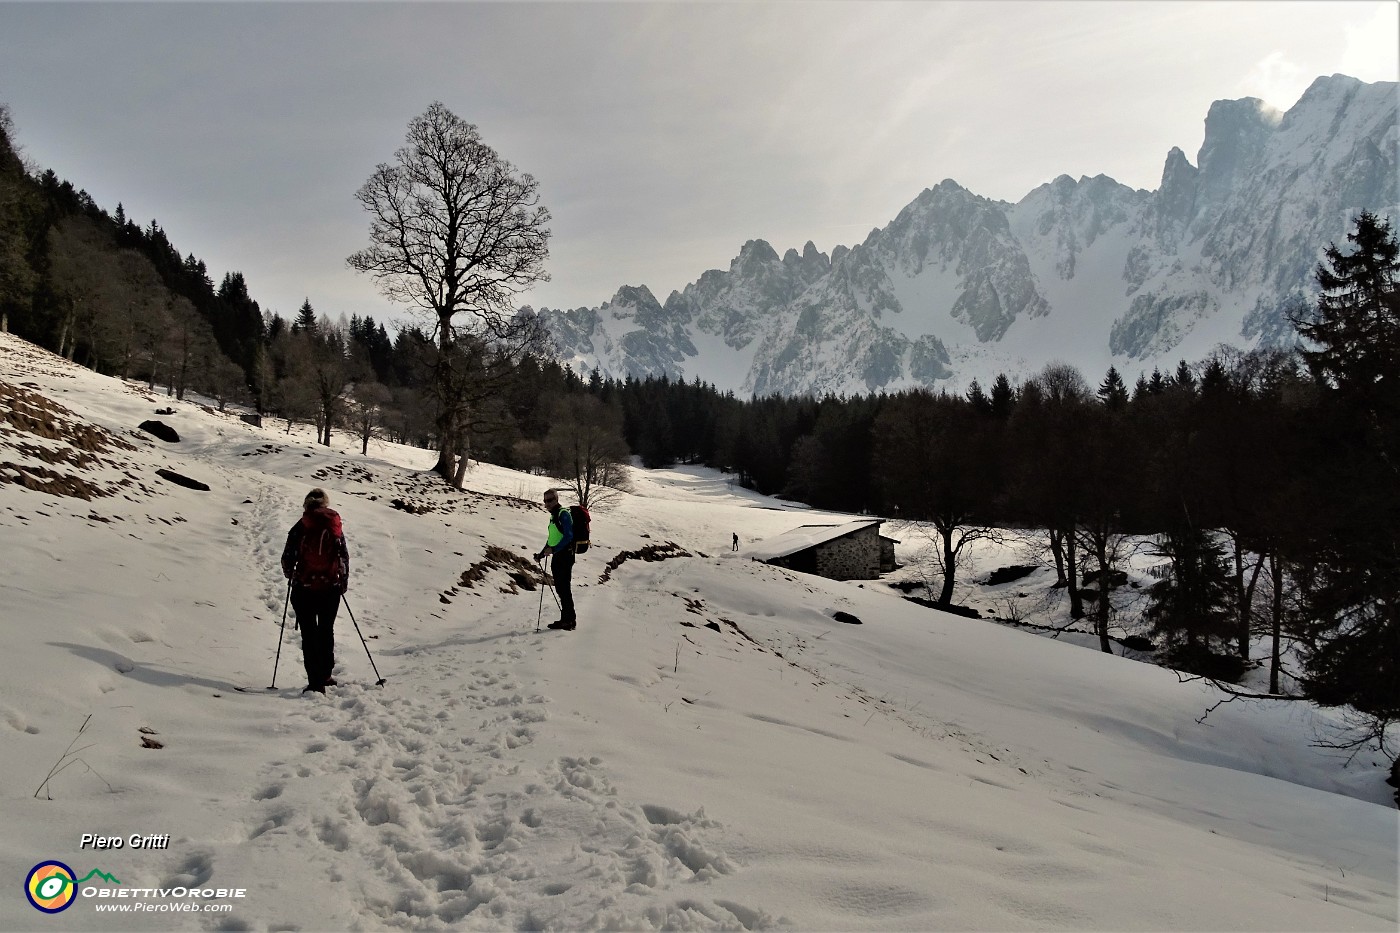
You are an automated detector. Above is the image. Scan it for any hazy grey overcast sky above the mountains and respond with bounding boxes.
[0,0,1400,321]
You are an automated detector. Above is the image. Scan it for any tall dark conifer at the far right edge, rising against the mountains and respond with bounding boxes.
[1295,213,1400,738]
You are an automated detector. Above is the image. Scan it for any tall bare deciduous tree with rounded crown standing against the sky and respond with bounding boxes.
[347,102,550,485]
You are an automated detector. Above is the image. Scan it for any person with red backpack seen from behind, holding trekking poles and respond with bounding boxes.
[281,489,350,693]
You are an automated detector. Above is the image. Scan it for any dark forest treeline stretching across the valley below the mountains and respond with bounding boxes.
[0,108,1400,756]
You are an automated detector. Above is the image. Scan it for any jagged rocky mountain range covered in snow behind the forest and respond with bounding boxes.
[539,74,1400,394]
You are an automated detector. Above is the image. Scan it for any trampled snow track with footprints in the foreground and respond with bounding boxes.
[228,622,773,929]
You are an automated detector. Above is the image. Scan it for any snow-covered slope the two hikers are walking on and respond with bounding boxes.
[0,335,1400,930]
